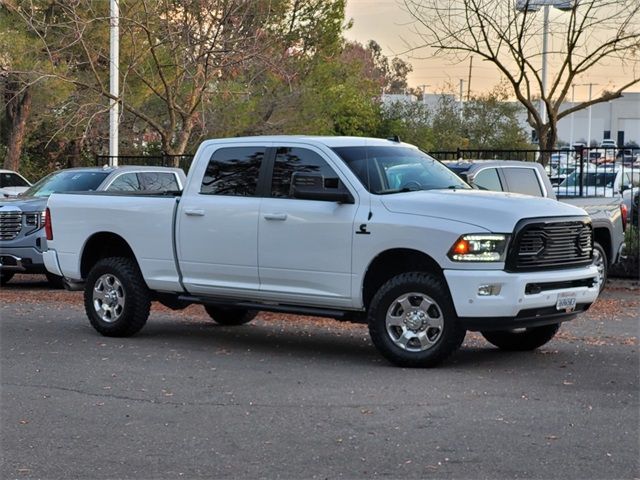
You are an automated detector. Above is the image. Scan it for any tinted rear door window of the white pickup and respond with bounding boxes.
[200,147,266,197]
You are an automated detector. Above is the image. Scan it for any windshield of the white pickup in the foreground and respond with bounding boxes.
[332,146,471,195]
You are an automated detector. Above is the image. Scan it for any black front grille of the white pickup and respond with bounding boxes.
[505,219,593,271]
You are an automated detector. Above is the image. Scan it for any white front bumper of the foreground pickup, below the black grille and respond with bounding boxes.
[444,266,598,330]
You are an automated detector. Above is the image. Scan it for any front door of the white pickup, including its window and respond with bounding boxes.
[258,146,357,306]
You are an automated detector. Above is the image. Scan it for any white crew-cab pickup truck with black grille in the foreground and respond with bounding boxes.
[45,136,598,367]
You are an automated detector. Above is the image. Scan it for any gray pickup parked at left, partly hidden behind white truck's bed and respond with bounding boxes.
[0,166,186,287]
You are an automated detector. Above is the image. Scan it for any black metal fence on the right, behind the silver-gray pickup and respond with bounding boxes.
[429,147,640,197]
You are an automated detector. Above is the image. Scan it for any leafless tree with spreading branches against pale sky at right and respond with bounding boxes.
[404,0,640,159]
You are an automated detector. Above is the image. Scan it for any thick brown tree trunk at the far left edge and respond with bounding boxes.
[4,79,31,171]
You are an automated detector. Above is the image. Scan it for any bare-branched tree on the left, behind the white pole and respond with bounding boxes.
[7,0,271,158]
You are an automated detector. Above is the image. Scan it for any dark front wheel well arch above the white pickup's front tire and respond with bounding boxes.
[362,248,449,308]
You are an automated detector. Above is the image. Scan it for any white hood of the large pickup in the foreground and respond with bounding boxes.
[382,190,586,233]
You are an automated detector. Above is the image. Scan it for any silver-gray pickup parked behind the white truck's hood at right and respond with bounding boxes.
[444,160,624,290]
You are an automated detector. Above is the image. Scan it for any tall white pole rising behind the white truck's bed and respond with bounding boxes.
[109,0,120,166]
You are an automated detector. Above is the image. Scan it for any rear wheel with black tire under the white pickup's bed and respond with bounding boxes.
[84,257,151,337]
